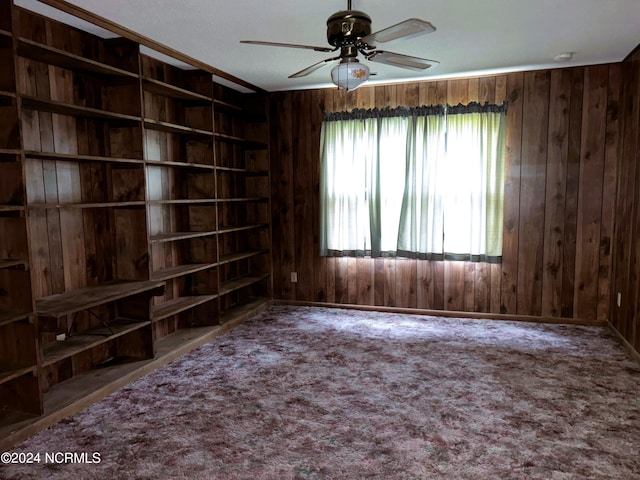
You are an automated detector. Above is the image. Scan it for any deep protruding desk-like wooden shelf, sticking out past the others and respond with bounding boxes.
[35,281,164,318]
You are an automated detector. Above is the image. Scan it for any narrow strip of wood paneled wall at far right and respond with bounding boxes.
[610,49,640,352]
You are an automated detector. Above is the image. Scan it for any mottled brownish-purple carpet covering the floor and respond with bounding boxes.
[0,306,640,480]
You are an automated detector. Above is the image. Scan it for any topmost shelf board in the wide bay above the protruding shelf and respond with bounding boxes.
[17,38,138,79]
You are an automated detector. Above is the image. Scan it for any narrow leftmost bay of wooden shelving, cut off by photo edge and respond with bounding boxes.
[0,0,43,437]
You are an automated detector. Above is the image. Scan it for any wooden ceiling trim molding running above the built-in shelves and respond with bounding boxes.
[39,0,266,93]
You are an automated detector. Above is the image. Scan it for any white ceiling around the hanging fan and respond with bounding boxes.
[15,0,640,91]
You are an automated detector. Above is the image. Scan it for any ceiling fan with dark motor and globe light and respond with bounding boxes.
[240,0,438,90]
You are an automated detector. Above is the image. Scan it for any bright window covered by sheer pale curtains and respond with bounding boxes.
[320,103,506,261]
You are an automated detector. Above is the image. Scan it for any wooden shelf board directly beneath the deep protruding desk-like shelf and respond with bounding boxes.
[42,319,151,367]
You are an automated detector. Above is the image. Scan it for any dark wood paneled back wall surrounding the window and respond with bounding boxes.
[271,64,624,321]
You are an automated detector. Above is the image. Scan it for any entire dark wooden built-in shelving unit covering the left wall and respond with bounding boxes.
[0,0,272,449]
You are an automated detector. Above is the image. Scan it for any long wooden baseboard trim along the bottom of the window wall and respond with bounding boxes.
[273,300,608,327]
